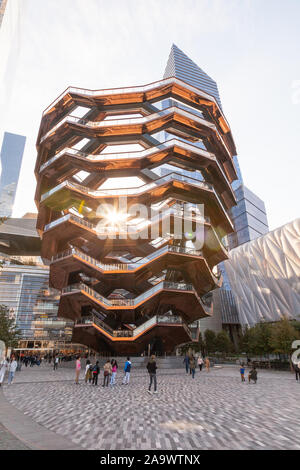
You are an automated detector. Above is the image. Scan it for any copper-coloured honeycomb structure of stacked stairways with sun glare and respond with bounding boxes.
[35,78,236,354]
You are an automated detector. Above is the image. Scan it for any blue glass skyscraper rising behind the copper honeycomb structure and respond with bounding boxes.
[160,44,269,339]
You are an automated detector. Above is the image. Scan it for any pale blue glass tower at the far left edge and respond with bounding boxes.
[0,132,26,217]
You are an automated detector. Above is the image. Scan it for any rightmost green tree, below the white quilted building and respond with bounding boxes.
[270,319,299,354]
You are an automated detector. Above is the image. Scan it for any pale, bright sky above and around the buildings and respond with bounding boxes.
[0,0,300,230]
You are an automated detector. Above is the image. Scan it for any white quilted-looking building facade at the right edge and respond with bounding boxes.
[224,219,300,326]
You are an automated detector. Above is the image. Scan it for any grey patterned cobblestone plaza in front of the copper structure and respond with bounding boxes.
[0,366,300,450]
